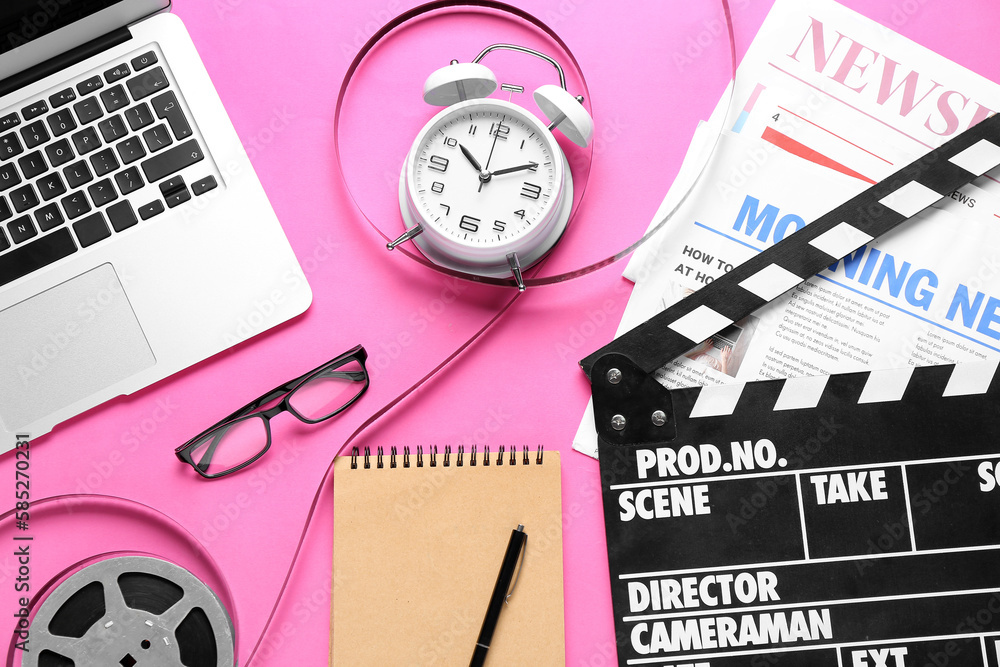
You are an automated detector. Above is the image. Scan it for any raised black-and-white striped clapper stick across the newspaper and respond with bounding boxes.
[580,115,1000,380]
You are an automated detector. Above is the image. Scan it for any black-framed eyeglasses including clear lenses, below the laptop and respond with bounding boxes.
[174,345,368,479]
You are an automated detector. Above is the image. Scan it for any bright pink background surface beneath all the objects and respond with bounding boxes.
[0,0,1000,667]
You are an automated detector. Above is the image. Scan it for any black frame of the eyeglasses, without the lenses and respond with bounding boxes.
[174,345,370,479]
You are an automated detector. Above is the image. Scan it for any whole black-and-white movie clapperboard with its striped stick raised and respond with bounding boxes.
[581,116,1000,667]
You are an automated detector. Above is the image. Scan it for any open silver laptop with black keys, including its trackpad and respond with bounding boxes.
[0,0,312,451]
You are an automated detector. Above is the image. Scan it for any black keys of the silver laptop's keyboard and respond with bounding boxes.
[0,51,218,286]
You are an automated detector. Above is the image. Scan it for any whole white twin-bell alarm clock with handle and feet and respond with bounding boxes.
[387,44,594,291]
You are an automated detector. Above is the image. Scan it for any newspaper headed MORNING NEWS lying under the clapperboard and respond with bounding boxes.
[574,0,1000,456]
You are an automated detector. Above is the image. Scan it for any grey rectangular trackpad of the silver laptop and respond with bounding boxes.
[0,264,156,431]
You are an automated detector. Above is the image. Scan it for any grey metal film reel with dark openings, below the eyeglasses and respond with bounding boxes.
[21,556,235,667]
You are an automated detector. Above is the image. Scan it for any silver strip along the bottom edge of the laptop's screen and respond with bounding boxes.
[0,0,171,80]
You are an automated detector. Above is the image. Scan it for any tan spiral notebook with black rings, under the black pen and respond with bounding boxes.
[330,447,566,667]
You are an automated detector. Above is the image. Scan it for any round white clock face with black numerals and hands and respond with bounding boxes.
[404,100,565,261]
